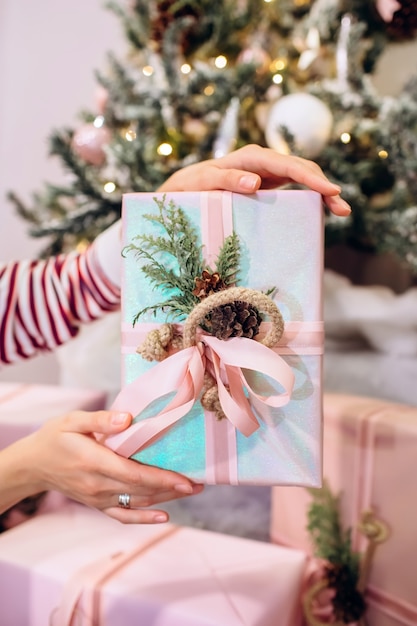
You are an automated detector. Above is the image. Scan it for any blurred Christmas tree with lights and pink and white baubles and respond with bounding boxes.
[10,0,417,274]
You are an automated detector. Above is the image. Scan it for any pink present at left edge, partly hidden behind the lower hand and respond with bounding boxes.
[0,382,106,532]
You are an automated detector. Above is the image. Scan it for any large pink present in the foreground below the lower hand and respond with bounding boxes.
[0,503,305,626]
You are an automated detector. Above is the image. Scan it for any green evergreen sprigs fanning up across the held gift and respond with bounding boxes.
[123,195,240,325]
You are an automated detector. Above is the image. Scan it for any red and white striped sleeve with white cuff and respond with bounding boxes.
[0,225,120,363]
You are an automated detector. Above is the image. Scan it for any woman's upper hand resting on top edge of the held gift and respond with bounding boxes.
[158,145,351,216]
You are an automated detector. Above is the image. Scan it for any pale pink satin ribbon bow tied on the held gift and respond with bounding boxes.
[106,335,294,457]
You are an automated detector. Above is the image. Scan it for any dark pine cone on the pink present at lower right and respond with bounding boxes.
[326,565,366,624]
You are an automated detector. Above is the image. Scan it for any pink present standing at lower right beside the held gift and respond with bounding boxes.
[271,394,417,626]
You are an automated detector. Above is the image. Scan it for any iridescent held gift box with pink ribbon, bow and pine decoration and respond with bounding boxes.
[108,190,323,486]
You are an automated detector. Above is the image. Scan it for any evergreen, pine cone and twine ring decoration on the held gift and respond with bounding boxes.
[123,195,284,420]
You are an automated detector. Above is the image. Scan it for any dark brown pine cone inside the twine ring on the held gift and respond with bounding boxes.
[203,300,262,339]
